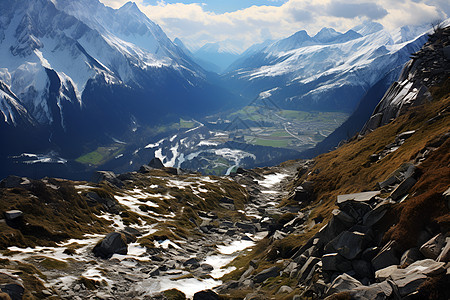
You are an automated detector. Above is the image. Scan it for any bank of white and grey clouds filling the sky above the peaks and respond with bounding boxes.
[101,0,450,50]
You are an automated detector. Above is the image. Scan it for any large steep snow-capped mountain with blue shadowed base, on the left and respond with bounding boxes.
[0,0,239,176]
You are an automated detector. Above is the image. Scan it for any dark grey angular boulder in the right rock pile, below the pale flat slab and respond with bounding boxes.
[325,231,367,260]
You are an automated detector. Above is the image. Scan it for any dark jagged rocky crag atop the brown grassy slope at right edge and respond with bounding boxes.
[361,27,450,134]
